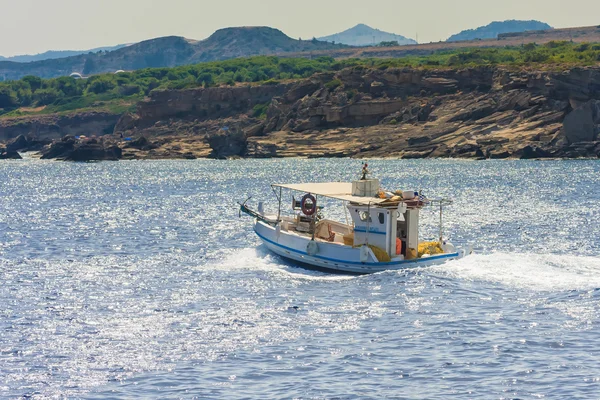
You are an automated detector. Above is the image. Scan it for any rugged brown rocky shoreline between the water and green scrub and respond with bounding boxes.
[0,67,600,161]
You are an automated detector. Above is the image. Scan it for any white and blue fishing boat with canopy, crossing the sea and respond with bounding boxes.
[240,168,471,274]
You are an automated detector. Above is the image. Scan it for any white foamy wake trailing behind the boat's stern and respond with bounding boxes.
[430,253,600,291]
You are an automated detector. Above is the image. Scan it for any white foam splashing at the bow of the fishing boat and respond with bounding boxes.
[210,246,356,281]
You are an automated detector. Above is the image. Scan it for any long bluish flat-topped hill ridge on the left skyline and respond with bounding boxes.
[0,27,344,80]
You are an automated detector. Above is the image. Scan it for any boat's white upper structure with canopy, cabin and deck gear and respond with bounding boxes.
[259,179,426,260]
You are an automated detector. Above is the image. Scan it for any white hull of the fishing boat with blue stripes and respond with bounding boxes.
[254,220,466,274]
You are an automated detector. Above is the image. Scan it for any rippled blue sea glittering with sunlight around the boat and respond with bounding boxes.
[0,160,600,399]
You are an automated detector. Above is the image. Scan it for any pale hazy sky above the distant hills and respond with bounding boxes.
[0,0,600,56]
